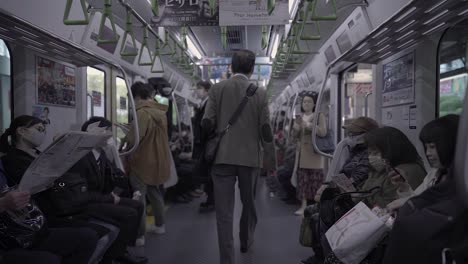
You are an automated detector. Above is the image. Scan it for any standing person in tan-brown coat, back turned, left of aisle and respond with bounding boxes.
[124,82,170,244]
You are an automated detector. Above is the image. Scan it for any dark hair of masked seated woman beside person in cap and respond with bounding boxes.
[365,127,422,167]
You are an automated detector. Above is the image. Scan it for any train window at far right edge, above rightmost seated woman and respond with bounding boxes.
[438,20,468,116]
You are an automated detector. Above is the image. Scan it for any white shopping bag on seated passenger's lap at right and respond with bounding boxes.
[325,202,389,264]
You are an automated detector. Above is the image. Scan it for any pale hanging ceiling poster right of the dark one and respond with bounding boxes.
[219,0,289,26]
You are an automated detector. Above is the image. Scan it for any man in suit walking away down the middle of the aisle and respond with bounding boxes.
[202,50,273,264]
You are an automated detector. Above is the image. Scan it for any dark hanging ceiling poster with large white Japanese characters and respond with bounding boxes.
[151,0,219,27]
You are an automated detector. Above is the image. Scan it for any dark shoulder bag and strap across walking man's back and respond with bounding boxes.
[204,84,258,164]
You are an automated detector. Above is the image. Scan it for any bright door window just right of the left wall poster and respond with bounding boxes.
[86,67,106,118]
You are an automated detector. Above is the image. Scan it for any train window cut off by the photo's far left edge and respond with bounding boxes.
[0,39,11,133]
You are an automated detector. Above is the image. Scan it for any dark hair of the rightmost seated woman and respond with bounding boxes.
[419,114,460,168]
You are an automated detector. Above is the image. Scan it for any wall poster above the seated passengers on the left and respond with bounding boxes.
[36,57,76,107]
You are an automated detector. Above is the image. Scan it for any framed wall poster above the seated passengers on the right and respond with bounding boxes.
[382,53,415,107]
